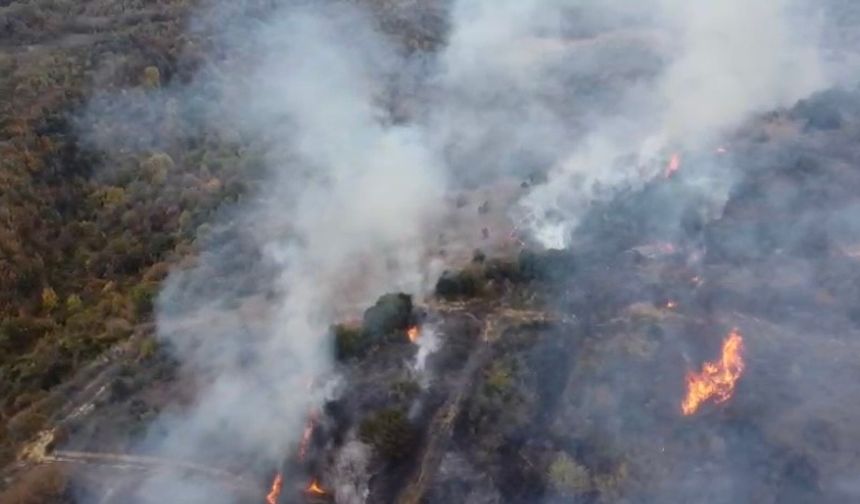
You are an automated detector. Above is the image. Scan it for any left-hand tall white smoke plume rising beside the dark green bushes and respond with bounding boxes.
[122,1,445,502]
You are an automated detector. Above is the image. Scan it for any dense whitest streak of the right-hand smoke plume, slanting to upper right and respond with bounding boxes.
[510,0,826,247]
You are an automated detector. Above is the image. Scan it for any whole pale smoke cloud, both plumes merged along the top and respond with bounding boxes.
[70,0,848,502]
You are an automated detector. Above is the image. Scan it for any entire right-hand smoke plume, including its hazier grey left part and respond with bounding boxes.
[440,0,827,248]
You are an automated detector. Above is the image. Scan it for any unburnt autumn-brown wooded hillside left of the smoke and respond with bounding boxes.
[0,1,241,461]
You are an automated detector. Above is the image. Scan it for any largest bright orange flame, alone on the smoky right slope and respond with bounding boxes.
[681,329,744,416]
